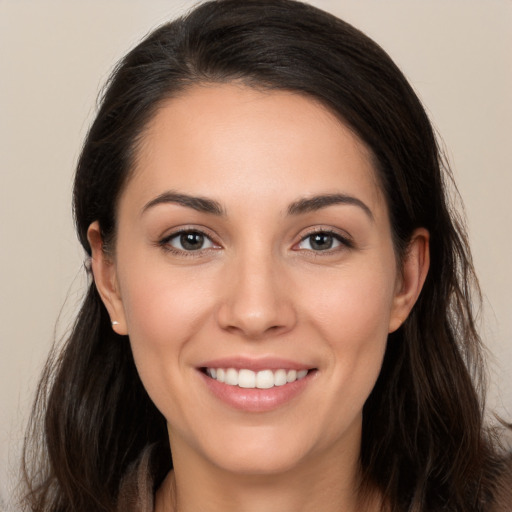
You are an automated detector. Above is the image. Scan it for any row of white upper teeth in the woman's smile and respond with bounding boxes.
[206,368,308,389]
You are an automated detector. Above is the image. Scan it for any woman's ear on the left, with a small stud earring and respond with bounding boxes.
[87,221,128,335]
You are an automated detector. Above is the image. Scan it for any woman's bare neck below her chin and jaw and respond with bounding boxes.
[155,424,381,512]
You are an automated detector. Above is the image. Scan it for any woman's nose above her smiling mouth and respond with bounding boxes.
[217,249,297,340]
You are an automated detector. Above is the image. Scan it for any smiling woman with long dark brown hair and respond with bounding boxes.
[22,0,512,512]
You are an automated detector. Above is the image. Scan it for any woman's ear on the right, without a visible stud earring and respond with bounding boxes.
[389,228,430,332]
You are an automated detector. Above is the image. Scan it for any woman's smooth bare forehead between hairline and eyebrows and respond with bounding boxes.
[126,84,382,218]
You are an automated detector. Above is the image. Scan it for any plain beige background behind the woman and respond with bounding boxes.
[0,0,512,509]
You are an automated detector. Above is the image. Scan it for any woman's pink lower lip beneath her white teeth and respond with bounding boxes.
[200,370,316,412]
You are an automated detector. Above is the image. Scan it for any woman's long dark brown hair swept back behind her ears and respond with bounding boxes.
[25,0,505,512]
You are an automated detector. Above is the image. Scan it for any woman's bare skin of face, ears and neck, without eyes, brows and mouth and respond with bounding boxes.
[89,84,428,512]
